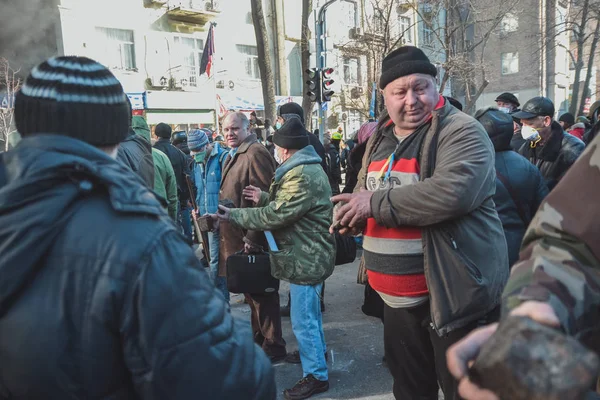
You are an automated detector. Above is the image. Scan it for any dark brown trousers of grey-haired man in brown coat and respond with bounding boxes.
[244,292,286,357]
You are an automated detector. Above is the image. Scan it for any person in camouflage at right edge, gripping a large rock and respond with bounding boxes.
[448,138,600,400]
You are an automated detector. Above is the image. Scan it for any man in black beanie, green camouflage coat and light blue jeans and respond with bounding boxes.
[219,118,335,400]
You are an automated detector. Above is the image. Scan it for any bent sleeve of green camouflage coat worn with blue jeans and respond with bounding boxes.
[230,169,318,231]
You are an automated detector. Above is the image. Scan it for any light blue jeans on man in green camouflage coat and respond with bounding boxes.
[290,283,329,381]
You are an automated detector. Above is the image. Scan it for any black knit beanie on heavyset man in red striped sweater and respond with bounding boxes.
[379,46,437,89]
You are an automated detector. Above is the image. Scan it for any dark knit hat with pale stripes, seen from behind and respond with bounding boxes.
[15,57,131,146]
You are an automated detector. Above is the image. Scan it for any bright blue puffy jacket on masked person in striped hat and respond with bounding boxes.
[193,143,228,215]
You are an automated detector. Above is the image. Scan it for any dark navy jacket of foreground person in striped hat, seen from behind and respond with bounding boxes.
[0,135,275,400]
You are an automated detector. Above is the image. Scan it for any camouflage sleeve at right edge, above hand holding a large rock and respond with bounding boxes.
[503,138,600,335]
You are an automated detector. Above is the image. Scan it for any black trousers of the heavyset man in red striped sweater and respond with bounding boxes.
[383,302,499,400]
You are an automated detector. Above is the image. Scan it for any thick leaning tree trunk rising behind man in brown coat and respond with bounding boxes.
[250,0,277,121]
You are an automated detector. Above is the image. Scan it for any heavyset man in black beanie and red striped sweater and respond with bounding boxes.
[333,46,509,400]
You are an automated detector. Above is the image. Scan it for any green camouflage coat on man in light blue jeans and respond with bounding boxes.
[230,146,335,285]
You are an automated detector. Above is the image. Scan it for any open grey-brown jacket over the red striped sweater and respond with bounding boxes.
[355,103,509,336]
